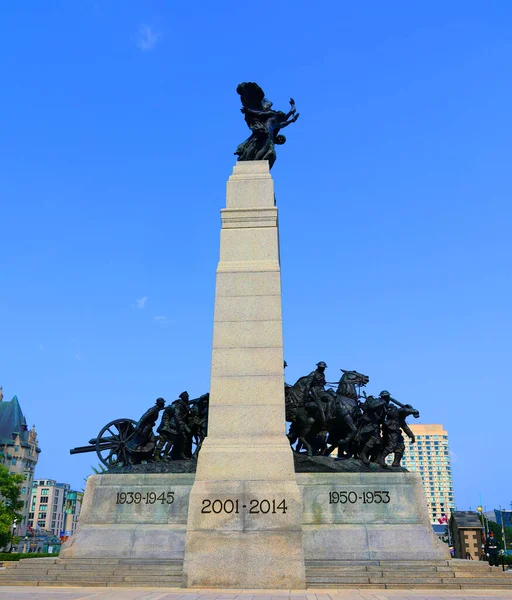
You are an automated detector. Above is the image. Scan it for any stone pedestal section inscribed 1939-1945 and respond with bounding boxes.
[59,473,194,561]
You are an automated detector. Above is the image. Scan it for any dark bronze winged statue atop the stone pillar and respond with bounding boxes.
[235,82,299,169]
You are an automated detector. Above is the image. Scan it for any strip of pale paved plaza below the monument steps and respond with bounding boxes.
[0,586,512,600]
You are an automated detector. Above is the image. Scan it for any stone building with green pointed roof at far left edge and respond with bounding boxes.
[0,387,41,536]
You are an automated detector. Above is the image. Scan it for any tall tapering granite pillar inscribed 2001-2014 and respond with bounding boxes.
[184,161,305,589]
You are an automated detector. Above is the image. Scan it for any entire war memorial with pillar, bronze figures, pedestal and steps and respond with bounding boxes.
[0,83,510,589]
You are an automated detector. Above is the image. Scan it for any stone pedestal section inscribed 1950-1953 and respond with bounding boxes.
[297,472,450,561]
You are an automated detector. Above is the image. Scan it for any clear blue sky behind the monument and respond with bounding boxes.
[0,0,512,509]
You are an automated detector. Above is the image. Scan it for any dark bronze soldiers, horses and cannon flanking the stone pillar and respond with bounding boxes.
[70,361,419,469]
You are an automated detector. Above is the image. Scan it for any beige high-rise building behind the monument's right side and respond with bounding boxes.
[402,423,455,523]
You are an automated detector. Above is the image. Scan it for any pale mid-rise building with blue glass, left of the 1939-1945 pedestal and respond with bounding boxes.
[28,479,83,537]
